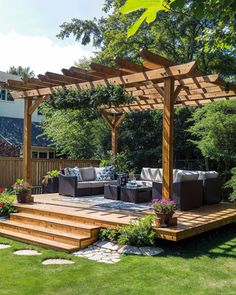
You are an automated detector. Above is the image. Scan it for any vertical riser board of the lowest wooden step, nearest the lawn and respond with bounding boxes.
[0,223,81,248]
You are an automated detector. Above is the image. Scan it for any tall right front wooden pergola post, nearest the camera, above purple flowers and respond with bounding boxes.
[162,77,175,200]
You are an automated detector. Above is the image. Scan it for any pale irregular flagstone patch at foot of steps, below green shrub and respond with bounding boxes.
[73,241,164,264]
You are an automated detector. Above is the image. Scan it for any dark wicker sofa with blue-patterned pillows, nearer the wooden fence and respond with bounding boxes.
[59,167,117,197]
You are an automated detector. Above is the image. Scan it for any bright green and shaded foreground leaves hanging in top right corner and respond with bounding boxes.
[120,0,236,51]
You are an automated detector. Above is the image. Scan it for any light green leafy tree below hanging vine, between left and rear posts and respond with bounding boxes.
[41,104,106,159]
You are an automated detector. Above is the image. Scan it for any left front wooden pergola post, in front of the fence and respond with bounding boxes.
[23,98,32,183]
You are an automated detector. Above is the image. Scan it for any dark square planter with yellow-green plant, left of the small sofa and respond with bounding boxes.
[42,170,60,194]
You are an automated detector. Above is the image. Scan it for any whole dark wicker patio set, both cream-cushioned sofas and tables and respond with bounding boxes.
[59,166,221,211]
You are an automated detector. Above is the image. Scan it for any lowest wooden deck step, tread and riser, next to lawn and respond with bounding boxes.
[0,220,92,247]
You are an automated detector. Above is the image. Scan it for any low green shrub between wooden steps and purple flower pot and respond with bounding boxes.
[100,215,155,247]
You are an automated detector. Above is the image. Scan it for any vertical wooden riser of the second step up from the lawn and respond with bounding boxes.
[11,214,99,237]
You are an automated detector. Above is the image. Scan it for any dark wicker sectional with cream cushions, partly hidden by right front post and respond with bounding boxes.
[137,168,222,211]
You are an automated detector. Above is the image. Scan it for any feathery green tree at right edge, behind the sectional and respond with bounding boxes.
[189,100,236,179]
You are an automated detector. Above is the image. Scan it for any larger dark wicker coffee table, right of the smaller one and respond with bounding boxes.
[120,185,152,204]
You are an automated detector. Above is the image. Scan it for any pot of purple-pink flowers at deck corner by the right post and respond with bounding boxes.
[152,199,176,226]
